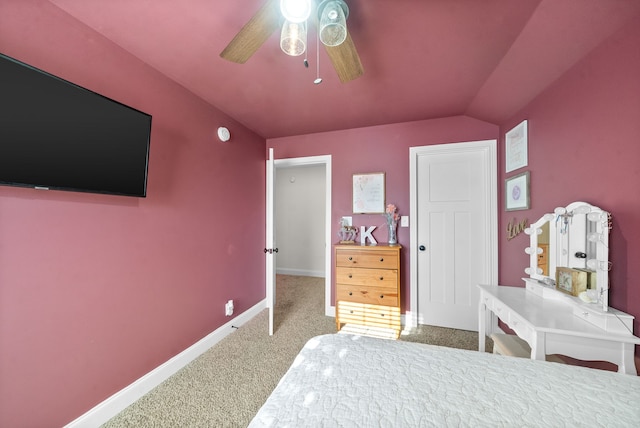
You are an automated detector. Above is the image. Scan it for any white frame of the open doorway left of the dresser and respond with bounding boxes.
[274,155,335,316]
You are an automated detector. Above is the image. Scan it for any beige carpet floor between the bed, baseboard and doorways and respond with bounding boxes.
[103,275,492,428]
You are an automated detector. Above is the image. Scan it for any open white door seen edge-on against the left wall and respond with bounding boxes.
[264,148,278,336]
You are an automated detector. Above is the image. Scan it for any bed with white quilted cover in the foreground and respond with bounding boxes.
[249,334,640,428]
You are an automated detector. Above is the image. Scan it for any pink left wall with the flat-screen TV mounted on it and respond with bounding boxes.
[0,1,265,427]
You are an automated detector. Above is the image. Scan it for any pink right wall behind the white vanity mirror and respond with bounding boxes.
[500,18,640,338]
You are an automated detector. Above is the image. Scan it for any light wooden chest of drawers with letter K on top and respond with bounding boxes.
[335,244,402,338]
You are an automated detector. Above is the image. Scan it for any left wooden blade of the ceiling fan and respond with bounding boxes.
[220,0,280,64]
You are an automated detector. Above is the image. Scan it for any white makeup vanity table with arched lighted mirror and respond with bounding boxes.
[478,202,640,375]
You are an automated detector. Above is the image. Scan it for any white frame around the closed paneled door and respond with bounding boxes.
[405,140,498,330]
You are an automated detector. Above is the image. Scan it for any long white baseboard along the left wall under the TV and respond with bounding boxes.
[65,300,267,428]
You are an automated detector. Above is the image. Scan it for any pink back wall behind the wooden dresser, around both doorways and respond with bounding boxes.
[267,116,498,312]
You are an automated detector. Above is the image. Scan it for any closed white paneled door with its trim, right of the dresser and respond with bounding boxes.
[411,140,497,331]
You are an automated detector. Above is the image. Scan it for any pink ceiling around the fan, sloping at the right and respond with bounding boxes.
[50,0,640,138]
